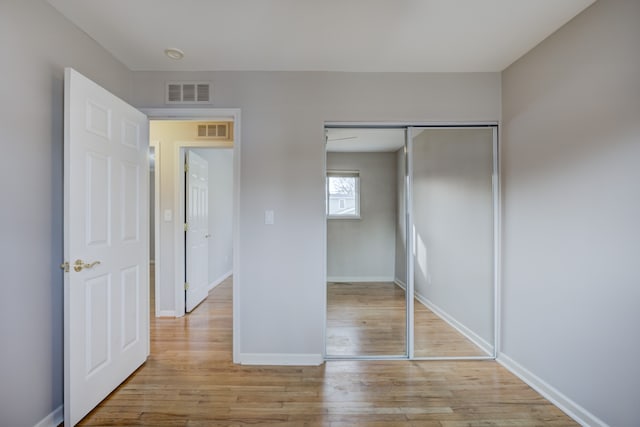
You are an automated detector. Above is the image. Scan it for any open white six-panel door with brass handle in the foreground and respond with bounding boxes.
[64,68,149,426]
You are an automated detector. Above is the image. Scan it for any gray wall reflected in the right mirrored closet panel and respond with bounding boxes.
[412,128,494,348]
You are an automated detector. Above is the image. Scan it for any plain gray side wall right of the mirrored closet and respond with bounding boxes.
[502,0,640,426]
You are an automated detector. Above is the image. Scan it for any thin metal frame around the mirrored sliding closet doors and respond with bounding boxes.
[322,121,502,360]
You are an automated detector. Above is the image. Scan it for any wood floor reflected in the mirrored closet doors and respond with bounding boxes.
[327,282,487,357]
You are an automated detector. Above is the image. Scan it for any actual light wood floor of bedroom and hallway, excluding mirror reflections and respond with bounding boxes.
[75,280,577,427]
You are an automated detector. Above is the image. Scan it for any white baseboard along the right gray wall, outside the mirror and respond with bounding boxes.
[496,353,607,427]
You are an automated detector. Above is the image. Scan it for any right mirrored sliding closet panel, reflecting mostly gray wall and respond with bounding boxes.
[409,127,497,358]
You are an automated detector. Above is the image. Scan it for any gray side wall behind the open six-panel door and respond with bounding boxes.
[0,0,132,427]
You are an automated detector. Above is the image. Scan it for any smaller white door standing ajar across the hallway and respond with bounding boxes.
[185,151,210,312]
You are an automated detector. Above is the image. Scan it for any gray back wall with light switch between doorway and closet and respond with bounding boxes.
[134,72,500,356]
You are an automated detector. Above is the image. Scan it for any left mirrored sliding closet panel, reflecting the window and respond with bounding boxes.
[326,128,407,358]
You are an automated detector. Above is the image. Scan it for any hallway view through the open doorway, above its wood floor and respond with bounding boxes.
[150,113,239,317]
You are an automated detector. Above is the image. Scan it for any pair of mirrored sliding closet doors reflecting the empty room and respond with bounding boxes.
[326,128,494,358]
